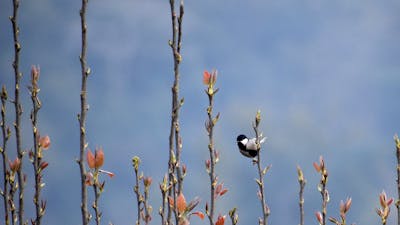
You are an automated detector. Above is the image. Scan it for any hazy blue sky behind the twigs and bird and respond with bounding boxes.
[0,0,400,224]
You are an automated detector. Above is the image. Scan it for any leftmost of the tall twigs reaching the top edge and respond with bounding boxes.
[10,0,25,225]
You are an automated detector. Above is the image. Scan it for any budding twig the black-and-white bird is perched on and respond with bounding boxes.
[253,111,270,225]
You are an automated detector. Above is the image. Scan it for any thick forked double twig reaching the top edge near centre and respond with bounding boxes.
[167,0,184,224]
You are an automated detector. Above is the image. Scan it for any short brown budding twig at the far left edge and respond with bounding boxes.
[0,86,11,225]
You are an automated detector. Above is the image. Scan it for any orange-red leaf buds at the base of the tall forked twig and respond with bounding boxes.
[168,193,203,225]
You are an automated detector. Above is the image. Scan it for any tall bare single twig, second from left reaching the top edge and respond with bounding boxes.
[78,0,90,225]
